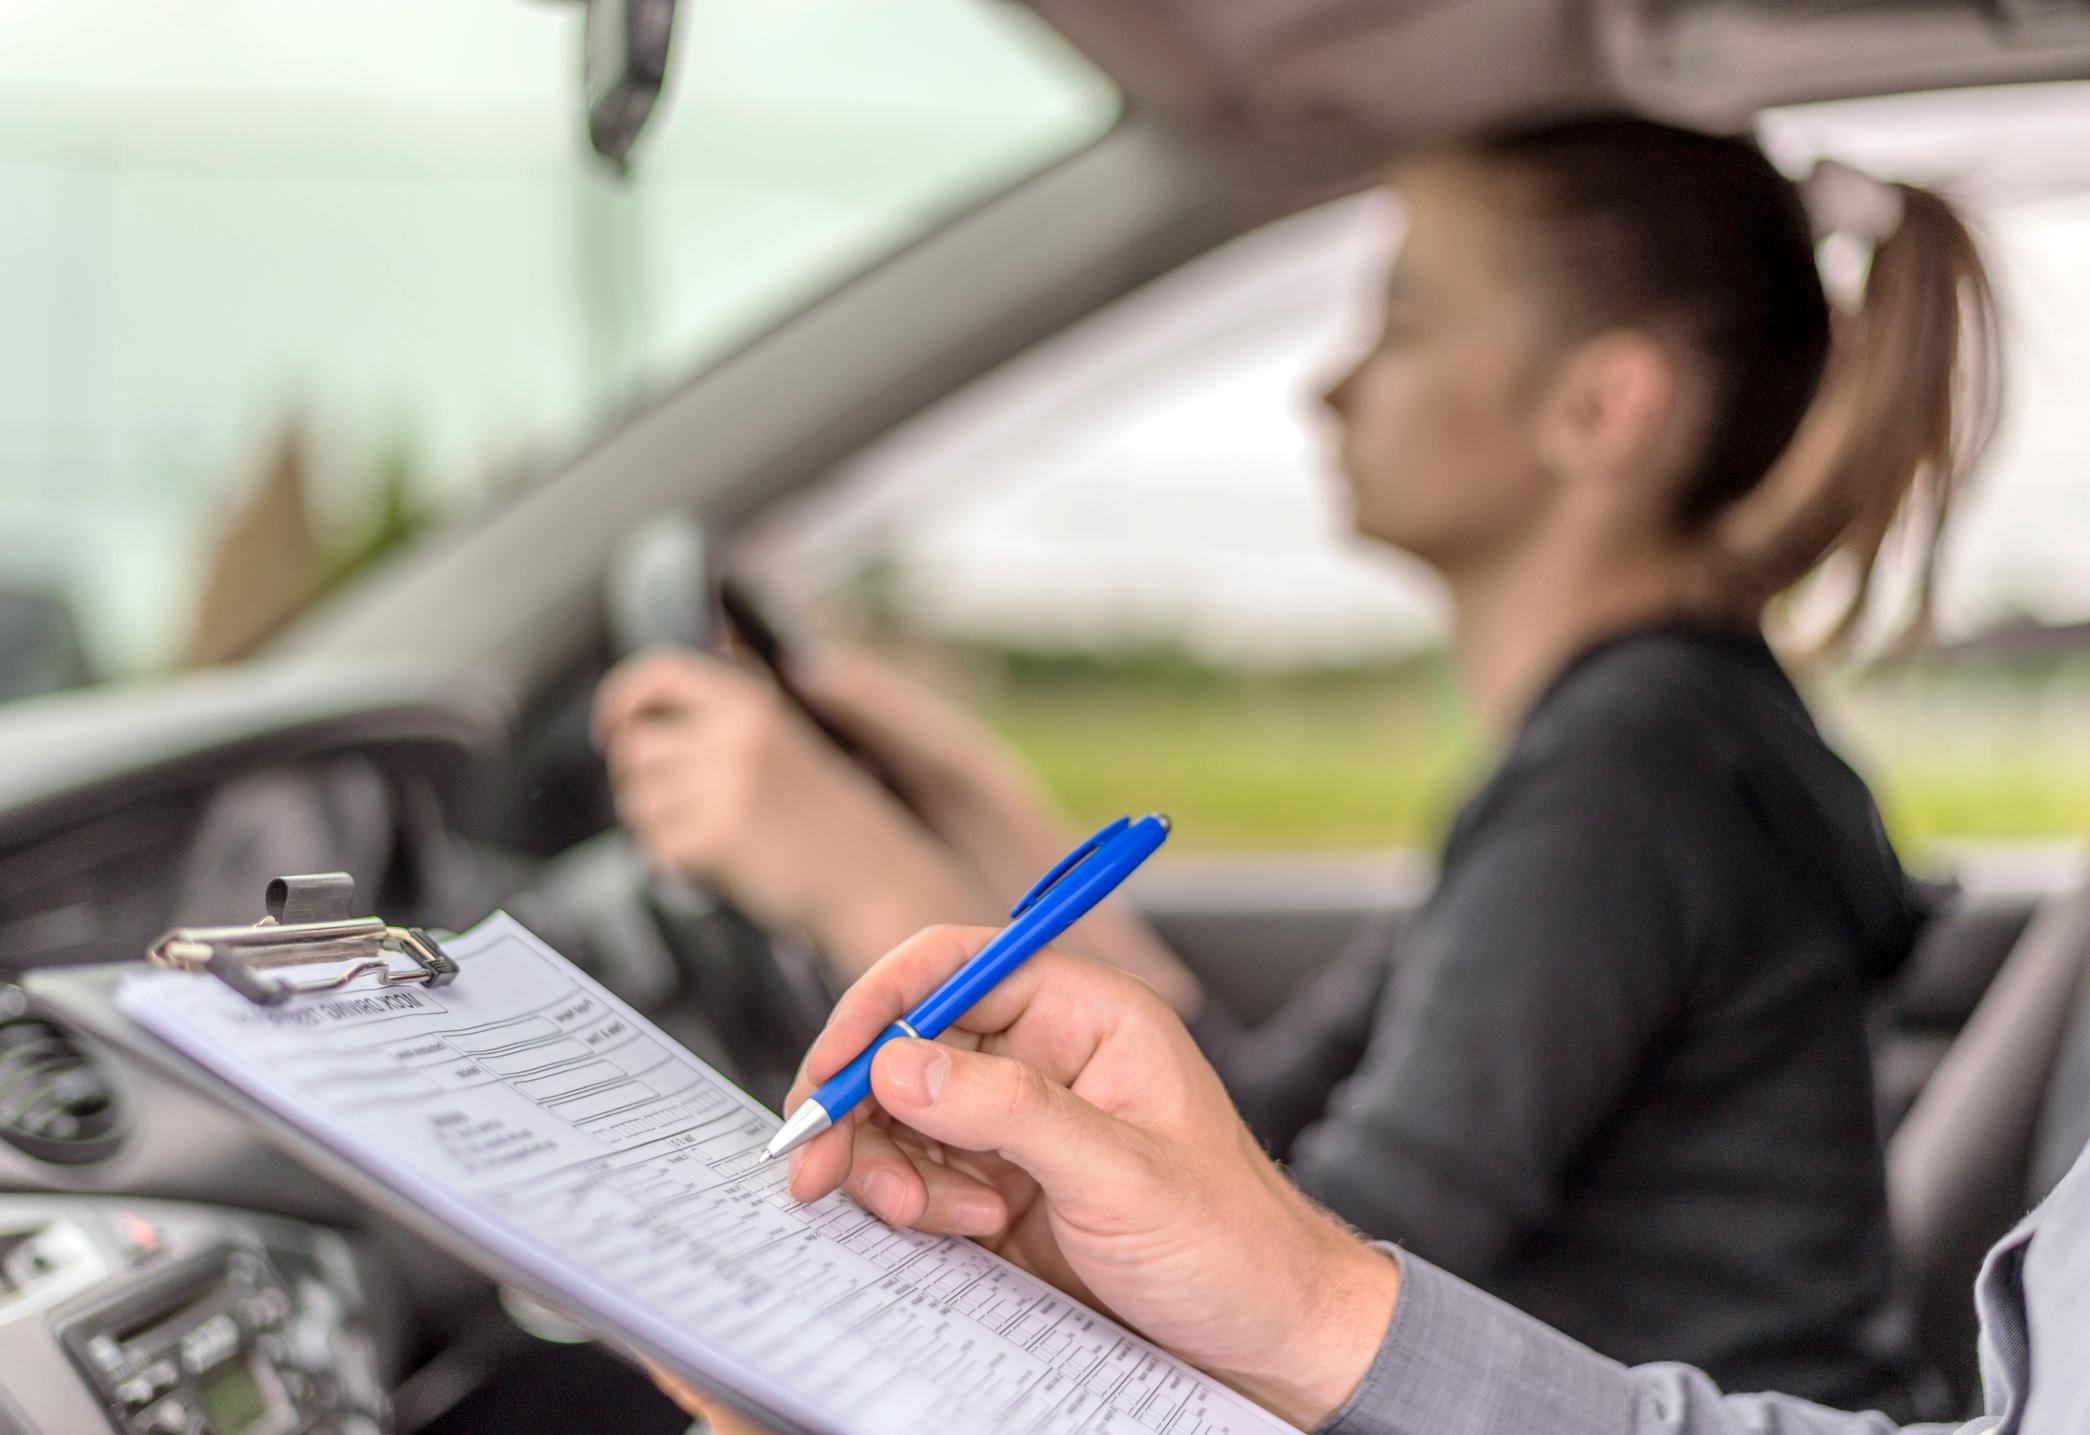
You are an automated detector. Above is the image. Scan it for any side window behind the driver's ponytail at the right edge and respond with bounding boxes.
[1762,84,2090,871]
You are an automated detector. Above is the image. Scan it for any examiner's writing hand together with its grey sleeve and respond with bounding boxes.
[635,927,1979,1435]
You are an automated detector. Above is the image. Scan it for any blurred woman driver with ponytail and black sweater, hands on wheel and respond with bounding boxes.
[598,119,1994,1412]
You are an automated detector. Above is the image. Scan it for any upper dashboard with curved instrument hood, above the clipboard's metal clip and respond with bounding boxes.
[0,671,506,971]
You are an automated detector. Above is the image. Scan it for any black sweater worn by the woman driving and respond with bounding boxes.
[1200,622,1923,1418]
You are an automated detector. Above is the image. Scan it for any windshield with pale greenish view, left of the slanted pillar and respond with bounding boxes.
[0,0,1118,698]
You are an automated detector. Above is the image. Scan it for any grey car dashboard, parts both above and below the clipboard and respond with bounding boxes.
[0,675,518,1435]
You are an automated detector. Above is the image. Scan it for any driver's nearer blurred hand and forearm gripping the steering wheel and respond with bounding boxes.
[594,650,993,978]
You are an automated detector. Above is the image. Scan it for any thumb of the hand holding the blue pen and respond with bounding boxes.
[872,1038,1141,1197]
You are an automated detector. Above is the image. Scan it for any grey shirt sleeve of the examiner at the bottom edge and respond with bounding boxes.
[1321,1247,1994,1435]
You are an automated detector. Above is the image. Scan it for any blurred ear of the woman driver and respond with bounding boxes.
[1538,330,1685,491]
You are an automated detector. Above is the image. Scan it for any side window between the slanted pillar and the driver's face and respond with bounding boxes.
[746,194,1469,848]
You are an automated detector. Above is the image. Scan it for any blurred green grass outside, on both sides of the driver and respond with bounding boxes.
[984,675,2090,858]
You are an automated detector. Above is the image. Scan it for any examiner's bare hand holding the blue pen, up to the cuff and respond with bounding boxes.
[790,927,1400,1427]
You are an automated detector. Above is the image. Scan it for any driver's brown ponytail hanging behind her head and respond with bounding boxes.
[1720,184,2002,650]
